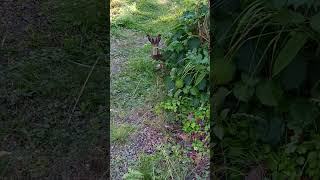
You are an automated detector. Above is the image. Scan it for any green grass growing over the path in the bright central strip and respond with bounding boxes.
[111,0,208,179]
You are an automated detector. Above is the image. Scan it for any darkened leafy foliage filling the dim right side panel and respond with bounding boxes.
[210,0,320,179]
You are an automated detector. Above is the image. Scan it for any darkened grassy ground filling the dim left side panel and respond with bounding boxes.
[0,0,108,179]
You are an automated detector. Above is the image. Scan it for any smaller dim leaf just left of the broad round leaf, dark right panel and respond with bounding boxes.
[233,82,254,102]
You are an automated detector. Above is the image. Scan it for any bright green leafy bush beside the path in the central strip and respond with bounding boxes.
[160,1,210,151]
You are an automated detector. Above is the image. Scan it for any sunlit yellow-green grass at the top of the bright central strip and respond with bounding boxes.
[111,0,183,34]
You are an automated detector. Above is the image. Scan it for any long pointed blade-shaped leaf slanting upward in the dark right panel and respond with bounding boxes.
[272,33,308,77]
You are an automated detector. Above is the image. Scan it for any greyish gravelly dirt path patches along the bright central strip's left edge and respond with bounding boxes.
[111,29,165,179]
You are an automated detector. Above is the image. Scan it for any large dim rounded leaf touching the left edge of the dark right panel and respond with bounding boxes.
[212,59,236,85]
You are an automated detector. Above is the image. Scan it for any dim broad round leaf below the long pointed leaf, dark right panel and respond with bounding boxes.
[256,80,283,106]
